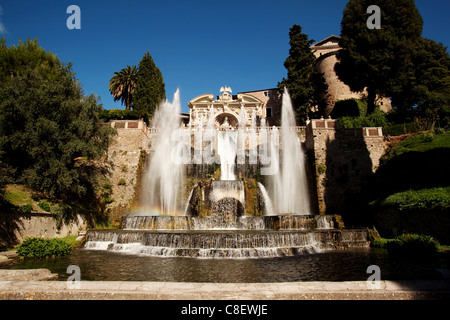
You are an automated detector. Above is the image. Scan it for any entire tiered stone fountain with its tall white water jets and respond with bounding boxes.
[85,90,368,258]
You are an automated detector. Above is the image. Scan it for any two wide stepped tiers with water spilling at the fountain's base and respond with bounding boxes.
[85,216,368,258]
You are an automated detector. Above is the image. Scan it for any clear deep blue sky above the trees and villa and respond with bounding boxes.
[0,0,450,112]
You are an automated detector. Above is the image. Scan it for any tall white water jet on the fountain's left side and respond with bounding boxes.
[141,90,184,215]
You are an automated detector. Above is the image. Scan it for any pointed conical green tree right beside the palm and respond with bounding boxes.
[133,51,166,115]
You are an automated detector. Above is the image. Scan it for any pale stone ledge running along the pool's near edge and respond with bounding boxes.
[0,280,450,300]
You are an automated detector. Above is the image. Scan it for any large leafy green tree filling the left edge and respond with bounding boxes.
[0,39,112,201]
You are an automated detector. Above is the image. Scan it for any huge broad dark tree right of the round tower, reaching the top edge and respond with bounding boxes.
[335,0,423,113]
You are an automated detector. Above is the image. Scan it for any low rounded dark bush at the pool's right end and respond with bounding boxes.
[385,234,439,258]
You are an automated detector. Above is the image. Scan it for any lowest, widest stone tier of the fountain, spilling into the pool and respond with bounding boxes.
[85,224,369,259]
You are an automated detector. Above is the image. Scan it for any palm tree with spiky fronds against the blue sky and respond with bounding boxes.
[109,66,137,110]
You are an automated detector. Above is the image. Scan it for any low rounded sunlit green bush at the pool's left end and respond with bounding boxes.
[17,238,72,258]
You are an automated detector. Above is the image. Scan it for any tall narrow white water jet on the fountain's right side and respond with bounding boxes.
[274,88,311,215]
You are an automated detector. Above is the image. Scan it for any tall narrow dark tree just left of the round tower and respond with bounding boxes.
[278,25,328,123]
